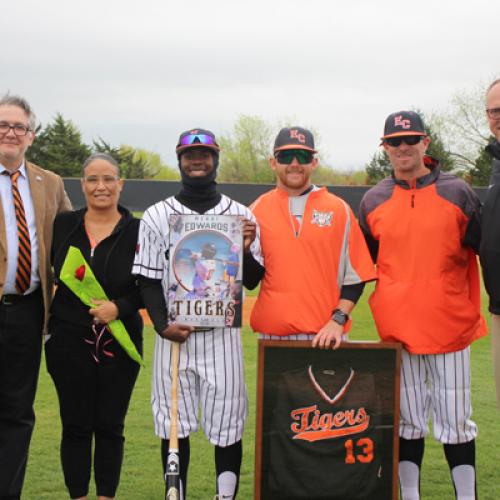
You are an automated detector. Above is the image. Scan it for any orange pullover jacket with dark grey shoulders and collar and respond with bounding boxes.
[359,161,486,354]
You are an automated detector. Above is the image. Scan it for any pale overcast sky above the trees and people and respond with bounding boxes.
[0,0,500,168]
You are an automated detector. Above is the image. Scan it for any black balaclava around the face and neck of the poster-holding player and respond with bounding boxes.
[175,146,221,214]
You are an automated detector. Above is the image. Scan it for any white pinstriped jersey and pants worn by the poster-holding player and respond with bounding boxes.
[133,195,261,447]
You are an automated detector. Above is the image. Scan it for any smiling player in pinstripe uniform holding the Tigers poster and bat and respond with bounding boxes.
[133,129,260,499]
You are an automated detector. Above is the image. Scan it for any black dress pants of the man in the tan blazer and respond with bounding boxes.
[0,291,43,500]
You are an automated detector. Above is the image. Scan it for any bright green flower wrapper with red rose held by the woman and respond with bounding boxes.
[60,246,145,366]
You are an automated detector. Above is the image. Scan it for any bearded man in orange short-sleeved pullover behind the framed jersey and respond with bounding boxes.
[246,127,375,349]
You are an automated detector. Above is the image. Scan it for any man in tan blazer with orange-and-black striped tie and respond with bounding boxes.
[0,95,71,500]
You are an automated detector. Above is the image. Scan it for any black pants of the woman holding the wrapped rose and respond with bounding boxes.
[45,322,141,498]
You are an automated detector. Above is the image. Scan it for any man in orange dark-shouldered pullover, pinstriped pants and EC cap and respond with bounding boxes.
[359,111,486,500]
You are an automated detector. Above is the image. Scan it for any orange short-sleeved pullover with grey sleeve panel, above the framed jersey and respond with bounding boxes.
[250,188,375,335]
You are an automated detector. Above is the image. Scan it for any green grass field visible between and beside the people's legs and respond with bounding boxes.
[23,290,500,500]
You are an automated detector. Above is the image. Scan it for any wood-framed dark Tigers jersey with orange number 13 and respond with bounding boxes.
[255,340,401,500]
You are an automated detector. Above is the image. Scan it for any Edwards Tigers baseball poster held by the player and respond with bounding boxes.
[168,214,243,328]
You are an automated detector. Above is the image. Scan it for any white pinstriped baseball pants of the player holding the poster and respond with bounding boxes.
[152,328,248,447]
